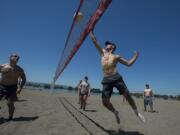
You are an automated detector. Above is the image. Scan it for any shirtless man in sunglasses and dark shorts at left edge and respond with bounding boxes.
[0,54,26,120]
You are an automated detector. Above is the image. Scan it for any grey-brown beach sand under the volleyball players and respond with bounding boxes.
[0,89,180,135]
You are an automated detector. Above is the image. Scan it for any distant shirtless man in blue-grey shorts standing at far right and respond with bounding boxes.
[143,84,154,112]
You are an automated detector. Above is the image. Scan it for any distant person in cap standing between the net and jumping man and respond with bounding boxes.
[79,76,90,111]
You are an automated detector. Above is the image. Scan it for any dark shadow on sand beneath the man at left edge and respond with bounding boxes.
[0,116,39,125]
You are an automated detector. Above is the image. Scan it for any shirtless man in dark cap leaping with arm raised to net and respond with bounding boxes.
[90,31,145,124]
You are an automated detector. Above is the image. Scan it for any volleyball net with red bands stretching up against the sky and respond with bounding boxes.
[54,0,112,82]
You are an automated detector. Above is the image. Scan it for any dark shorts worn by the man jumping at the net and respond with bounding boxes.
[101,73,128,98]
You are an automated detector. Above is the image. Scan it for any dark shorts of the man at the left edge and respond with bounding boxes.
[0,85,17,101]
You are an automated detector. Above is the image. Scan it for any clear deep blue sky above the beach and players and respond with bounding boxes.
[0,0,180,94]
